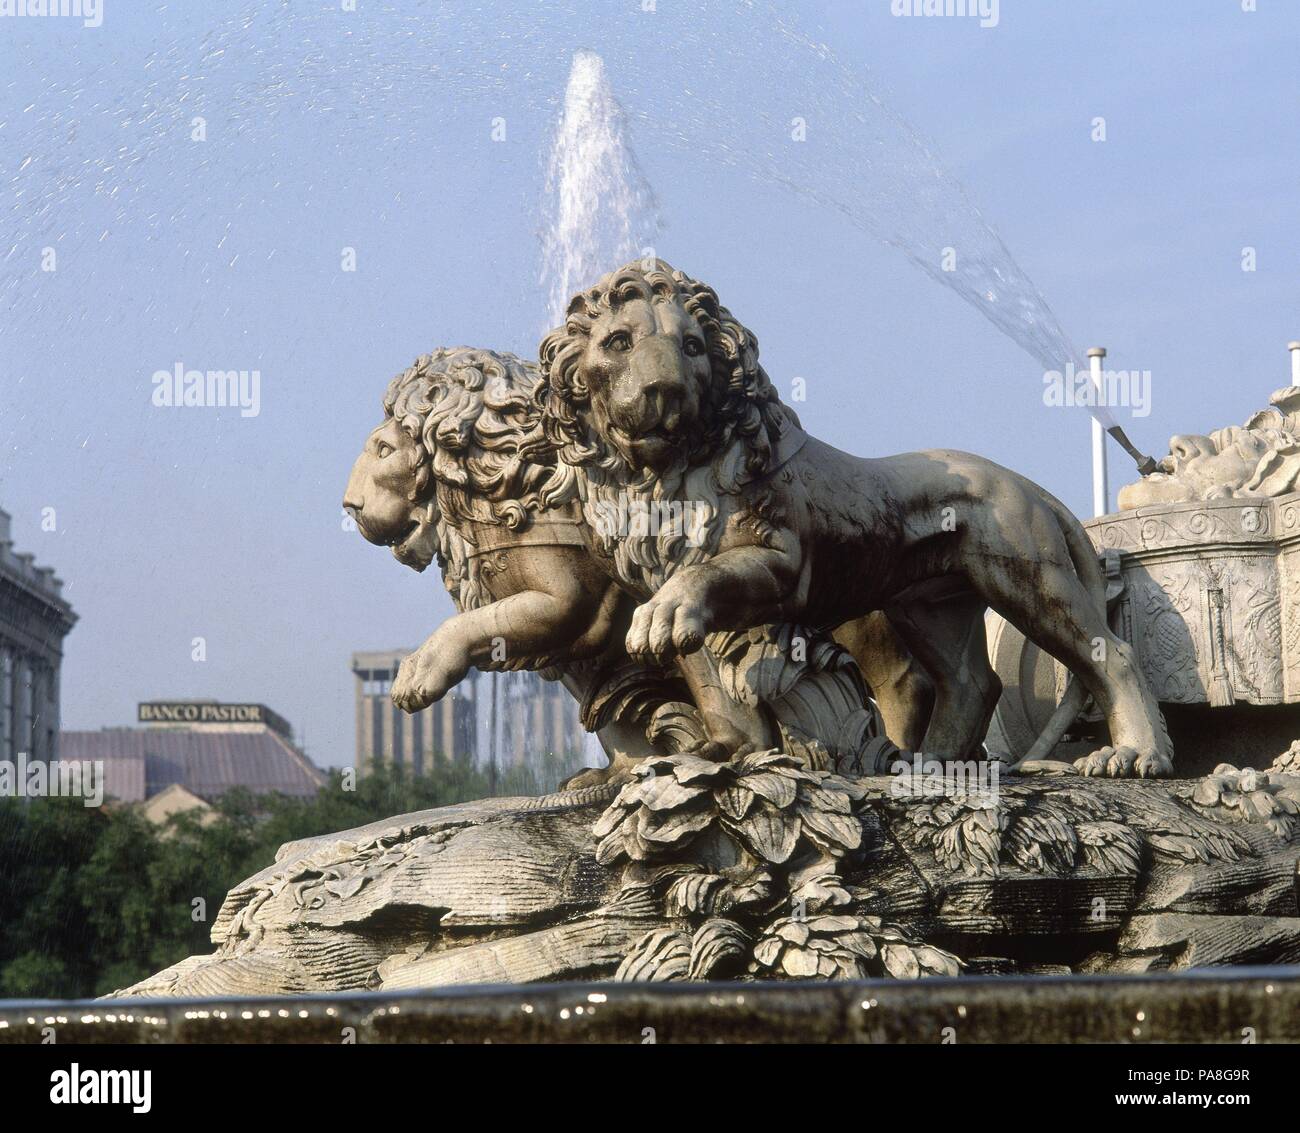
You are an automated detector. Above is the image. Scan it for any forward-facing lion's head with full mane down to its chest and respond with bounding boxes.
[541,260,798,592]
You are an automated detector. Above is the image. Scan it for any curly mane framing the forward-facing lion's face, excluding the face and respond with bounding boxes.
[540,260,800,592]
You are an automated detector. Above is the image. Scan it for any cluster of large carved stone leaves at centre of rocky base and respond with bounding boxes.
[594,748,961,980]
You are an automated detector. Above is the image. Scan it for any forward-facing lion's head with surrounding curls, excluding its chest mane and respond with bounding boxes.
[541,260,784,479]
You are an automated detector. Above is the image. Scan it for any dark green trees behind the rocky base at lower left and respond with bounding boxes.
[0,759,576,999]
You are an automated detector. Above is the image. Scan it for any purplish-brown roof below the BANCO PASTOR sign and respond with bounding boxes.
[59,728,324,803]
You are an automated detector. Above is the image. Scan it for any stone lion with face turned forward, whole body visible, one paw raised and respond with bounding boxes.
[541,260,1173,776]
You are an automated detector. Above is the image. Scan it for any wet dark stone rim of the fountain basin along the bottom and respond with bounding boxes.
[0,968,1300,1045]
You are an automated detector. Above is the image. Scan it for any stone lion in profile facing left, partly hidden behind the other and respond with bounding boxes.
[343,347,686,786]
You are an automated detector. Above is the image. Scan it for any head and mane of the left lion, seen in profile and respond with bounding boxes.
[343,347,572,609]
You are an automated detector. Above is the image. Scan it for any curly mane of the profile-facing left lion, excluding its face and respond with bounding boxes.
[384,347,576,609]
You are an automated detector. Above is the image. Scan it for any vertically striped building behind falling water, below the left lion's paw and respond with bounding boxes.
[352,650,586,772]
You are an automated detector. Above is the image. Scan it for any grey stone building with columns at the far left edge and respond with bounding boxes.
[0,511,77,760]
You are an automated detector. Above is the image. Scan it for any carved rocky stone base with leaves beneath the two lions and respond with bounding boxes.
[111,750,1300,995]
